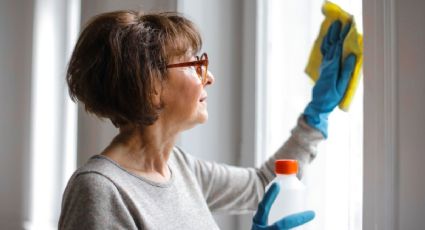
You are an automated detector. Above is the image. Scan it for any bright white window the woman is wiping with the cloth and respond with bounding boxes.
[258,0,363,230]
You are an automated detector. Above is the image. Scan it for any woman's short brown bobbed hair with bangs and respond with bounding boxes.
[66,10,202,127]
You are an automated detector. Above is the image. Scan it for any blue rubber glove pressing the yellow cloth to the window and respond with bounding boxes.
[304,21,356,138]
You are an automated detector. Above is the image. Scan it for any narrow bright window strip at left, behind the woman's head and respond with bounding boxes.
[23,0,80,229]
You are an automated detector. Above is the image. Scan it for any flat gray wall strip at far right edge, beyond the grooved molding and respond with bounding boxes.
[395,0,425,229]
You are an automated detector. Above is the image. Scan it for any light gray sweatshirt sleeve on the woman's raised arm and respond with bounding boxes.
[180,116,323,214]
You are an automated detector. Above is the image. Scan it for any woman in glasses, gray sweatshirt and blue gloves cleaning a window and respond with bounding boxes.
[59,11,355,230]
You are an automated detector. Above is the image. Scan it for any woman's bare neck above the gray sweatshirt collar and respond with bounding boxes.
[101,122,177,182]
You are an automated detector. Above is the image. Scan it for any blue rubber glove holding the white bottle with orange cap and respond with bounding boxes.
[251,183,315,230]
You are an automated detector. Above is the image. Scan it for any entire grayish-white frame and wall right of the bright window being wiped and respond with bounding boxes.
[363,0,425,230]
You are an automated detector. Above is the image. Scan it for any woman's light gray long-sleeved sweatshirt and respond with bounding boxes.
[59,117,323,230]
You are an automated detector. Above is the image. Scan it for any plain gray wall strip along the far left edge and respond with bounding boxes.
[0,0,33,229]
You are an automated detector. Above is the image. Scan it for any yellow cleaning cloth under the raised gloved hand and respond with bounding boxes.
[305,1,363,111]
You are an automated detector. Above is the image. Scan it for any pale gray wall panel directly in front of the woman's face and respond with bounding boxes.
[179,0,243,164]
